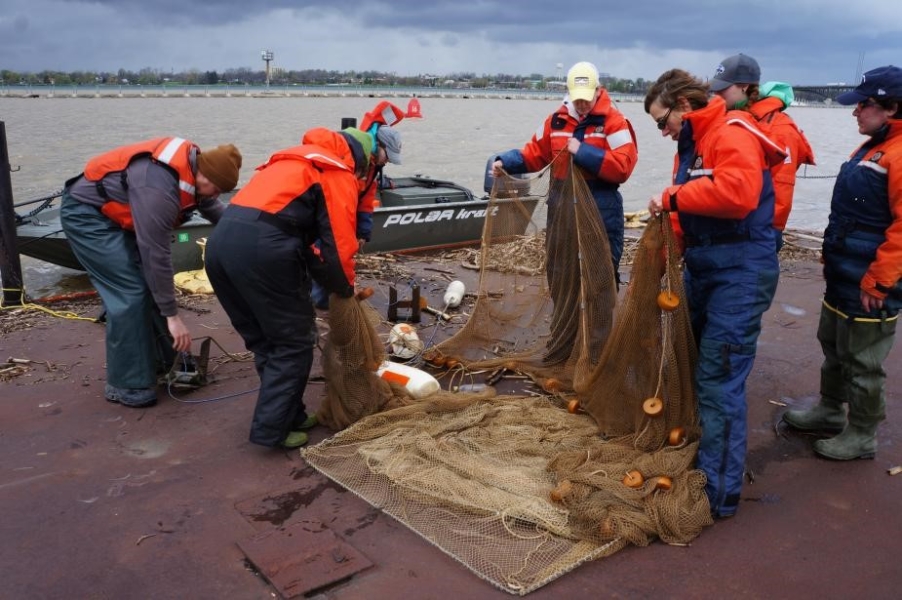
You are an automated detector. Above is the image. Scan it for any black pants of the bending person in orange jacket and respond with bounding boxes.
[206,205,316,446]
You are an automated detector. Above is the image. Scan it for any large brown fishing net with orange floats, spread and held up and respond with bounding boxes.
[303,155,711,595]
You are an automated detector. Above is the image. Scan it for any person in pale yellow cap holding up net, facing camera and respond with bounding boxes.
[492,62,639,281]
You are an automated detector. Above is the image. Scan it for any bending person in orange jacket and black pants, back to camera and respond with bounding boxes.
[206,128,373,448]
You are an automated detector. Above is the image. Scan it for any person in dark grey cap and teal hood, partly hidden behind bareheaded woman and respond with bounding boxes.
[710,54,814,245]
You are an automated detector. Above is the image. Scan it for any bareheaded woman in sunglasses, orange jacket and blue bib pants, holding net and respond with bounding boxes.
[645,69,786,517]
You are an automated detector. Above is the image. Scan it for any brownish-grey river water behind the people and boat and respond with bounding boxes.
[0,96,864,297]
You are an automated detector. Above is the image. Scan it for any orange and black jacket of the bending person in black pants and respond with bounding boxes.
[231,127,358,288]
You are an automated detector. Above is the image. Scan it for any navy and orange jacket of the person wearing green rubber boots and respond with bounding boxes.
[824,119,902,316]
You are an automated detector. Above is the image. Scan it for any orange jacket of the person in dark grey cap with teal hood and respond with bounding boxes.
[749,97,814,231]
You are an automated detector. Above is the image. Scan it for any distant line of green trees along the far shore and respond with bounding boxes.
[0,67,652,94]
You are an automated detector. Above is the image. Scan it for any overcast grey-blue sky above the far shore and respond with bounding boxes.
[0,0,902,85]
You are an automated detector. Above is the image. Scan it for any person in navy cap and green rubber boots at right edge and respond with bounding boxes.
[783,65,902,460]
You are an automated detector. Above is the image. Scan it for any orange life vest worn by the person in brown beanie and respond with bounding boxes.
[83,137,197,231]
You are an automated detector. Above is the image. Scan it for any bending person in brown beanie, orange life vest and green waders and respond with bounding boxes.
[60,137,241,408]
